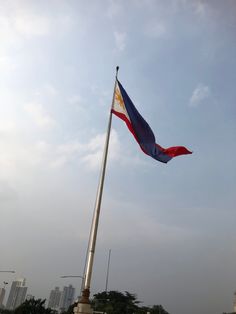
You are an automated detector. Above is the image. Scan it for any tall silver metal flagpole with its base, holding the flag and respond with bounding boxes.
[74,66,119,314]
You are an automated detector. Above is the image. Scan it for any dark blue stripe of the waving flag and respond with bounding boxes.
[118,81,172,163]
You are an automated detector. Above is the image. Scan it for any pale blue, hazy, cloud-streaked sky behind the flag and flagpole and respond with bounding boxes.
[0,0,236,314]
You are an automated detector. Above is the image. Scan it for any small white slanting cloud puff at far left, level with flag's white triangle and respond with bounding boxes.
[24,103,56,128]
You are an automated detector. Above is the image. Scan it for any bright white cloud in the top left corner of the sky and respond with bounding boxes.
[0,0,73,44]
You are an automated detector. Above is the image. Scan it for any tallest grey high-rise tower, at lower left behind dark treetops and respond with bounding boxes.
[6,278,27,310]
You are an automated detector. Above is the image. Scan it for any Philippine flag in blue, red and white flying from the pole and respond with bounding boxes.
[111,80,192,163]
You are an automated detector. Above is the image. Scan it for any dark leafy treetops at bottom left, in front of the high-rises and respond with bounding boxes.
[13,299,56,314]
